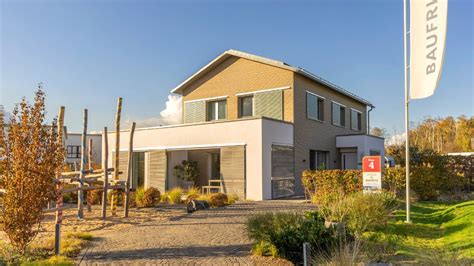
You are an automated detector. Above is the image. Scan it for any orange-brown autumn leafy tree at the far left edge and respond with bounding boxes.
[0,87,64,253]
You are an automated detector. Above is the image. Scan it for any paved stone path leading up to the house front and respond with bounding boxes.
[78,200,311,265]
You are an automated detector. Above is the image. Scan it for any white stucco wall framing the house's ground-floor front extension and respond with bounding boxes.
[108,118,293,200]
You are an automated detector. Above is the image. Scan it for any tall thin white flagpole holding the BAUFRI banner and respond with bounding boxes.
[403,0,411,223]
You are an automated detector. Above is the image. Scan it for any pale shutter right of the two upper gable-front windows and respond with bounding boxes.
[254,90,283,120]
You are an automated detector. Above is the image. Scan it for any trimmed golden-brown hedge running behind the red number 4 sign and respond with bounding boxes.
[302,160,469,204]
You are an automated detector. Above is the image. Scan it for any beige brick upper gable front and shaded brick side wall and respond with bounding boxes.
[178,53,367,194]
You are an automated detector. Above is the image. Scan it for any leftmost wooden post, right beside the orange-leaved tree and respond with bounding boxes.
[54,106,66,255]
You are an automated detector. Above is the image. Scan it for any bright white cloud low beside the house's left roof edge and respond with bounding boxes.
[125,95,182,127]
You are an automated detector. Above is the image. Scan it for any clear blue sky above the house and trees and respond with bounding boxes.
[0,0,474,133]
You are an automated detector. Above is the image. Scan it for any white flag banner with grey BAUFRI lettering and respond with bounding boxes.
[410,0,448,99]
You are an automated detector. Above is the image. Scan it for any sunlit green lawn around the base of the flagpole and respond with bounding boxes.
[384,201,474,260]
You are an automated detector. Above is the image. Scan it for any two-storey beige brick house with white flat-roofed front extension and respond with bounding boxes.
[103,50,384,200]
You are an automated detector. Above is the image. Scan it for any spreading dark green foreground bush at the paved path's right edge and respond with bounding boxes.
[246,212,336,263]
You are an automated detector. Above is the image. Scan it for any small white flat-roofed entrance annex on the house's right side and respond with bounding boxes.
[336,135,385,169]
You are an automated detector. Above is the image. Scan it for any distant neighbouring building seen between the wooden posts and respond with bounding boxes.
[64,132,102,169]
